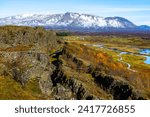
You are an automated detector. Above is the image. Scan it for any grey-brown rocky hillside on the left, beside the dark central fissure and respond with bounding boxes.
[0,26,57,99]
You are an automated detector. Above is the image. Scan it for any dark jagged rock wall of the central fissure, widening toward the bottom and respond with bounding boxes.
[51,50,96,100]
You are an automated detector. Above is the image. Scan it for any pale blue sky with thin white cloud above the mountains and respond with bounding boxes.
[0,0,150,26]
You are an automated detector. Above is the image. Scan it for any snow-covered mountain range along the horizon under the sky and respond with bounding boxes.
[0,12,136,30]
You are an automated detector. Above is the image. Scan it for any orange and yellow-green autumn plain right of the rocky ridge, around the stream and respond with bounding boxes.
[65,36,150,98]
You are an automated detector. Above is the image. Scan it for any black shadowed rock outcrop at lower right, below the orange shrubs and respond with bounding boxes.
[91,67,144,100]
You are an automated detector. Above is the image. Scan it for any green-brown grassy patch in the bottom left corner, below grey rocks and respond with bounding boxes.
[0,77,43,100]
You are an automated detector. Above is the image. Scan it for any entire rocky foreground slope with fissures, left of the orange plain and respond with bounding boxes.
[0,26,146,100]
